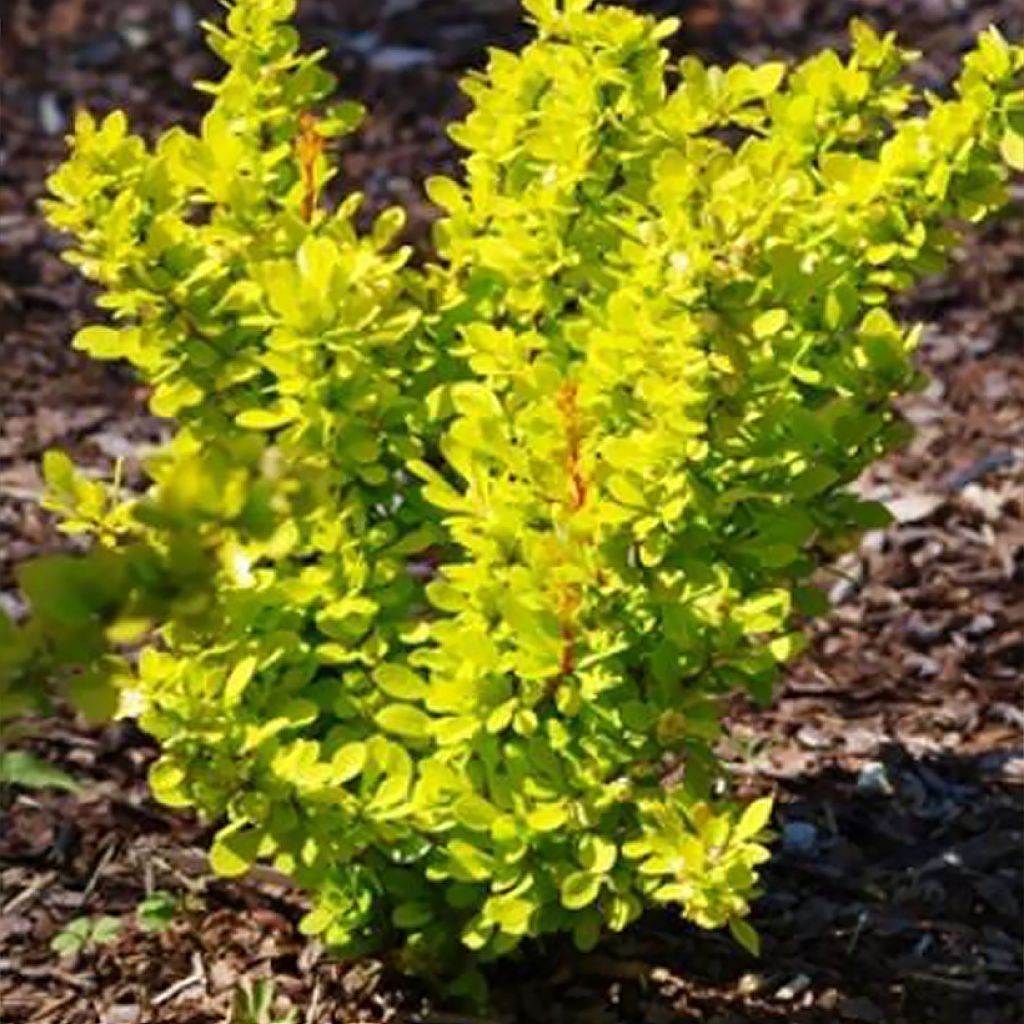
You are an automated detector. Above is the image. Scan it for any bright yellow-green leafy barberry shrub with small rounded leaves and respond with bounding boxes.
[3,0,1024,984]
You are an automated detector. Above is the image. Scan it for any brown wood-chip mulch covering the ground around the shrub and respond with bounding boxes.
[0,0,1024,1024]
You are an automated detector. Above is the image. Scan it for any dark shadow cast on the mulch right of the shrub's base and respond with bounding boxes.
[495,745,1024,1024]
